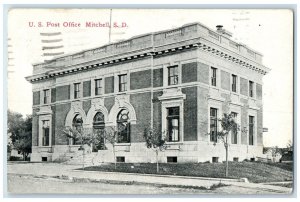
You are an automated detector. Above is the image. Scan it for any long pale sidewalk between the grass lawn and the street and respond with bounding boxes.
[8,163,292,194]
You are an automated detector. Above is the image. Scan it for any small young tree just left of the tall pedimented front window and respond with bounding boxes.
[144,128,167,173]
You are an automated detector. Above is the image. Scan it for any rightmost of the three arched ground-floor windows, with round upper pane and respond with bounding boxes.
[117,109,130,143]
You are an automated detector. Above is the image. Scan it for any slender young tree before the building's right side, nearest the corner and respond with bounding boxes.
[216,113,239,177]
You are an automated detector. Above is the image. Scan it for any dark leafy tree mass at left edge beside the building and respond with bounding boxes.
[7,110,32,161]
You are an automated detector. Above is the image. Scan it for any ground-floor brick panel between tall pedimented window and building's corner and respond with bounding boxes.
[182,87,198,141]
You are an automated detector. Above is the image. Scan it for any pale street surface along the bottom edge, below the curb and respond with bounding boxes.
[8,175,211,194]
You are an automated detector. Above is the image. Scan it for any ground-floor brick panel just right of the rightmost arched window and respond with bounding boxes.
[130,93,151,142]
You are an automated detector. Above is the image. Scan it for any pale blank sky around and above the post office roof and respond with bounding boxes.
[8,9,293,147]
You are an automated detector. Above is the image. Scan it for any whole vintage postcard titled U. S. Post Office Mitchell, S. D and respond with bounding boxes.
[7,8,294,196]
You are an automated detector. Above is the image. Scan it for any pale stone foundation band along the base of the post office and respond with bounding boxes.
[31,141,263,163]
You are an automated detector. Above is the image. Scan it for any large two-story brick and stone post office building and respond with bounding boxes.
[26,23,269,162]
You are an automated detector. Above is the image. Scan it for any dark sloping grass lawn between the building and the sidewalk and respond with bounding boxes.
[85,162,293,183]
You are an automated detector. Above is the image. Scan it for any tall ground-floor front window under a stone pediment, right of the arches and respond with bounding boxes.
[167,107,179,142]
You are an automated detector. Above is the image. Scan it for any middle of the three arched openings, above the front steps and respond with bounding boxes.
[93,112,106,152]
